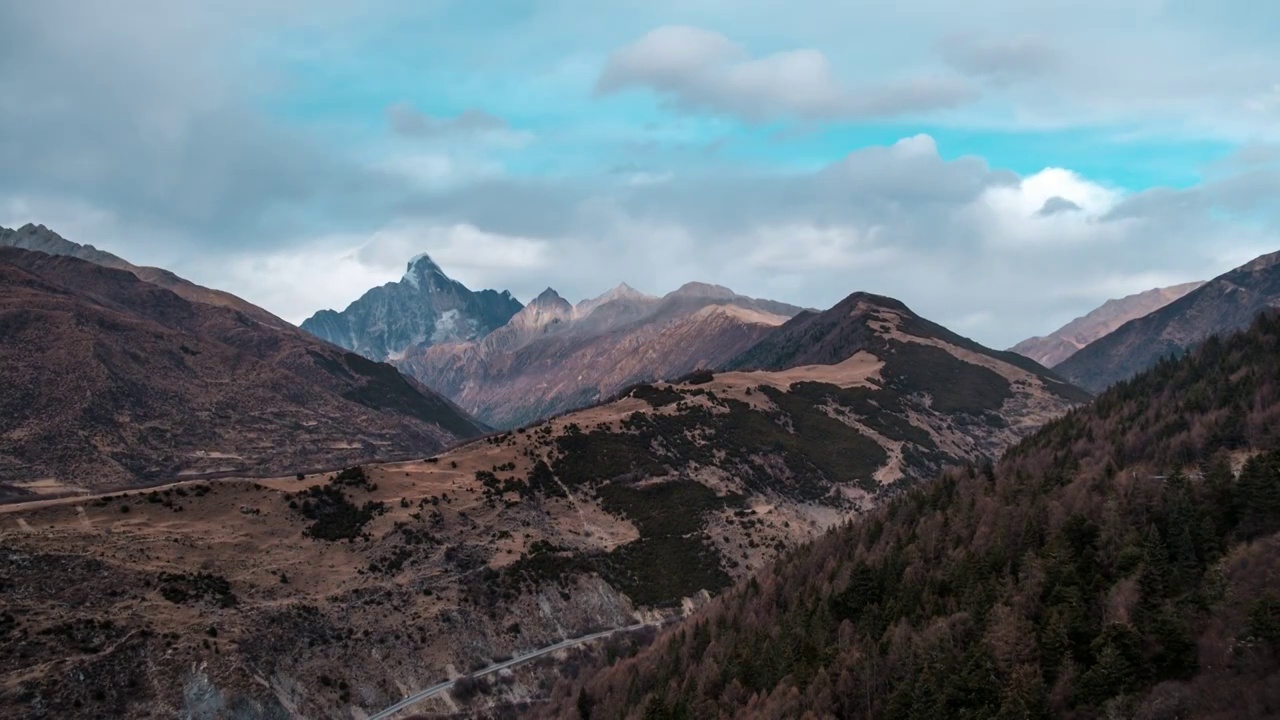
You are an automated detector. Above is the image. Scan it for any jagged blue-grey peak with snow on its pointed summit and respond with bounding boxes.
[302,255,521,361]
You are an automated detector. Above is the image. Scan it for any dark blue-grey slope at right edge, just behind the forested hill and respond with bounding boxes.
[1055,252,1280,392]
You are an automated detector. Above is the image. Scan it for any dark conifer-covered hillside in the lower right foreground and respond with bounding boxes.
[531,311,1280,719]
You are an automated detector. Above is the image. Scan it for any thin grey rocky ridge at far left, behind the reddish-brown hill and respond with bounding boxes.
[0,224,293,328]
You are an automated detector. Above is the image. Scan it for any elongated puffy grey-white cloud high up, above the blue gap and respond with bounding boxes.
[595,26,977,122]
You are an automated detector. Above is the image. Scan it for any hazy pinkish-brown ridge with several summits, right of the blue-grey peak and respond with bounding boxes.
[399,283,800,428]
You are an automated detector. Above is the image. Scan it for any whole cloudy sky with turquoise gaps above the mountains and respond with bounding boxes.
[0,0,1280,347]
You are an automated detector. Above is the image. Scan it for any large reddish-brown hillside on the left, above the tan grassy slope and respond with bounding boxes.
[0,247,481,495]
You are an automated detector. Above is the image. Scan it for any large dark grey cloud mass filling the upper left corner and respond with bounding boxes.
[0,0,404,250]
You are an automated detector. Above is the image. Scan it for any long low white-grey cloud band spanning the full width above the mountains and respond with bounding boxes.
[0,135,1280,346]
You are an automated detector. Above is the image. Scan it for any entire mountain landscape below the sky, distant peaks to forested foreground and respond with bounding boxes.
[0,221,1280,720]
